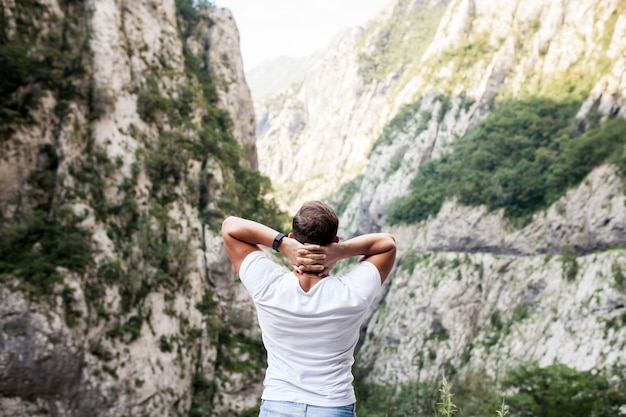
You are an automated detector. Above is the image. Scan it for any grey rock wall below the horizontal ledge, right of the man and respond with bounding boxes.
[358,245,626,384]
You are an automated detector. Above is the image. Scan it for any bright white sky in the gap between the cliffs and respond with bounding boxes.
[214,0,391,72]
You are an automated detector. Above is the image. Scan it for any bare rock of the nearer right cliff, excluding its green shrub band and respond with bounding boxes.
[342,1,626,384]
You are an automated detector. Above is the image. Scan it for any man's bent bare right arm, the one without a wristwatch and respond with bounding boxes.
[310,233,396,282]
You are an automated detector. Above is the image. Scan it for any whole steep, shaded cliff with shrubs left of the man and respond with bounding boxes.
[0,0,267,416]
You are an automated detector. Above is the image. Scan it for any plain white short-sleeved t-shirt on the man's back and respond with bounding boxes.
[239,251,381,407]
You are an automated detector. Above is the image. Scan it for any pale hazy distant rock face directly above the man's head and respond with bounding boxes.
[255,29,390,210]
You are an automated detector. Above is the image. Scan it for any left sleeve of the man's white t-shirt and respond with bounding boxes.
[239,251,287,300]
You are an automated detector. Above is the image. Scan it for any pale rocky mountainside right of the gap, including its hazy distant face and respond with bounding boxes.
[256,0,626,404]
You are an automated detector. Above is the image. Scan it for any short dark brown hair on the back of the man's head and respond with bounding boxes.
[292,201,339,245]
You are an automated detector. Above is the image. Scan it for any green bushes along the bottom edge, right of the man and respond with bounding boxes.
[355,363,626,417]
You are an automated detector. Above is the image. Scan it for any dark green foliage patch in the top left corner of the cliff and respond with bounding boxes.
[0,0,90,140]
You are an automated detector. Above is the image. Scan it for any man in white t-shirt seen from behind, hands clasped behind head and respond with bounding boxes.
[222,201,396,417]
